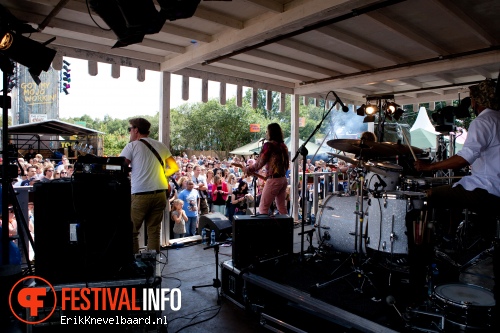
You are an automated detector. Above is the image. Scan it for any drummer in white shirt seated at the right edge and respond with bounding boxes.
[410,80,500,317]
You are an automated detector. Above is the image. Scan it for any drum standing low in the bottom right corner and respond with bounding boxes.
[433,283,495,332]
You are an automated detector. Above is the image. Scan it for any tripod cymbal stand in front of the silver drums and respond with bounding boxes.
[314,154,380,294]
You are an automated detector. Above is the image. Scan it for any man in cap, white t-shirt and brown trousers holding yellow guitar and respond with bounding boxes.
[120,118,179,253]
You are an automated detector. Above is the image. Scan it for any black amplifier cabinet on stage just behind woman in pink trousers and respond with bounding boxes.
[232,215,293,269]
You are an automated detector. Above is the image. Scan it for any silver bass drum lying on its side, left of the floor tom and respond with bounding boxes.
[316,195,357,253]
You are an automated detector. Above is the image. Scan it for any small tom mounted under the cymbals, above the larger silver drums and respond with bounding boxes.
[366,162,403,191]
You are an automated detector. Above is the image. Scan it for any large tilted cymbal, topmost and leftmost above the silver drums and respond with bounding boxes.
[326,139,398,157]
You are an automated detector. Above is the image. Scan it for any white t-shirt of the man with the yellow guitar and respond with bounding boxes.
[120,138,172,194]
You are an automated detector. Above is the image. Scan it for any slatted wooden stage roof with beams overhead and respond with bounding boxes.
[2,0,500,105]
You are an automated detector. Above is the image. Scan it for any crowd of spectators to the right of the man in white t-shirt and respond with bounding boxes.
[170,154,348,236]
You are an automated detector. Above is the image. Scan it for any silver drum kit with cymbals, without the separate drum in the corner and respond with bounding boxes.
[318,139,425,255]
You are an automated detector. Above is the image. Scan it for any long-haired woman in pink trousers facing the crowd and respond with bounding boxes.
[244,123,289,215]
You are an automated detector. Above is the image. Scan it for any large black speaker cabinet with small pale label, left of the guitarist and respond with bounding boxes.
[33,179,133,283]
